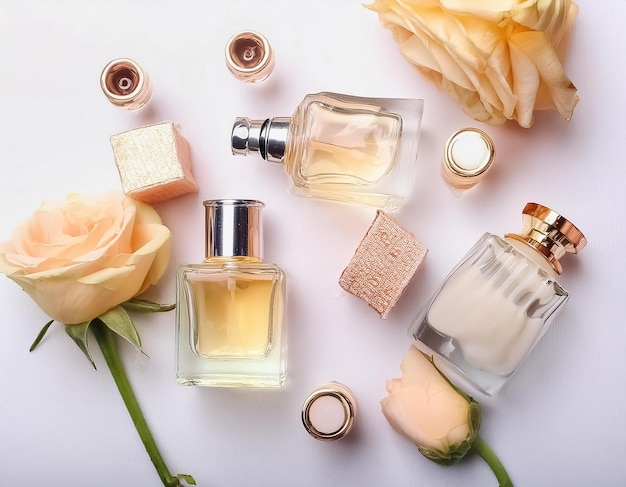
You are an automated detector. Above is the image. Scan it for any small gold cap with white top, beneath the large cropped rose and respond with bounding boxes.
[441,128,495,188]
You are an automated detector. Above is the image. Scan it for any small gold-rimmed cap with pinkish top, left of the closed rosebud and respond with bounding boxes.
[302,382,357,441]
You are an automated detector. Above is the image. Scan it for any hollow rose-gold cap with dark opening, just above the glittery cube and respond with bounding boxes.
[100,58,152,110]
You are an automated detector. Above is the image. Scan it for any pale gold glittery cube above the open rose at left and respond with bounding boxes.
[111,122,198,203]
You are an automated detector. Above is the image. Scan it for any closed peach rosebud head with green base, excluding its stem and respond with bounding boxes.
[381,346,480,465]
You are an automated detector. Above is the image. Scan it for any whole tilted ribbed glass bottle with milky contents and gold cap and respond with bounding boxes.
[409,203,587,394]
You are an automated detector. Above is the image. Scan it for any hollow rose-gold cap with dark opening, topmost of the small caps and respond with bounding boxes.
[226,31,274,83]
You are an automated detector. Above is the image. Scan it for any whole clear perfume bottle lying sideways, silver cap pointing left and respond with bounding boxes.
[231,92,423,211]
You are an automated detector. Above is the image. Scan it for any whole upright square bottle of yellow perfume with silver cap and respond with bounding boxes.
[176,200,287,387]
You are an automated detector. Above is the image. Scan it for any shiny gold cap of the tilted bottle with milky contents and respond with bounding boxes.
[505,203,587,274]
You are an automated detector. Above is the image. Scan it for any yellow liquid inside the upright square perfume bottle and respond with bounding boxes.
[189,275,275,359]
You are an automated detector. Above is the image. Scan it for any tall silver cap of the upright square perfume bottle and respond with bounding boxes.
[203,199,264,259]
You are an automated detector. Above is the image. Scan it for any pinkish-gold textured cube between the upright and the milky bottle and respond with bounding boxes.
[339,210,428,319]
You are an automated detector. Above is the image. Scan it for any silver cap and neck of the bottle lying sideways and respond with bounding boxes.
[230,117,291,162]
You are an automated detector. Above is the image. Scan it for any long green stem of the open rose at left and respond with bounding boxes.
[91,320,196,487]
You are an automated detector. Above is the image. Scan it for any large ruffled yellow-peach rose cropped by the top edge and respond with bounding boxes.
[367,0,578,127]
